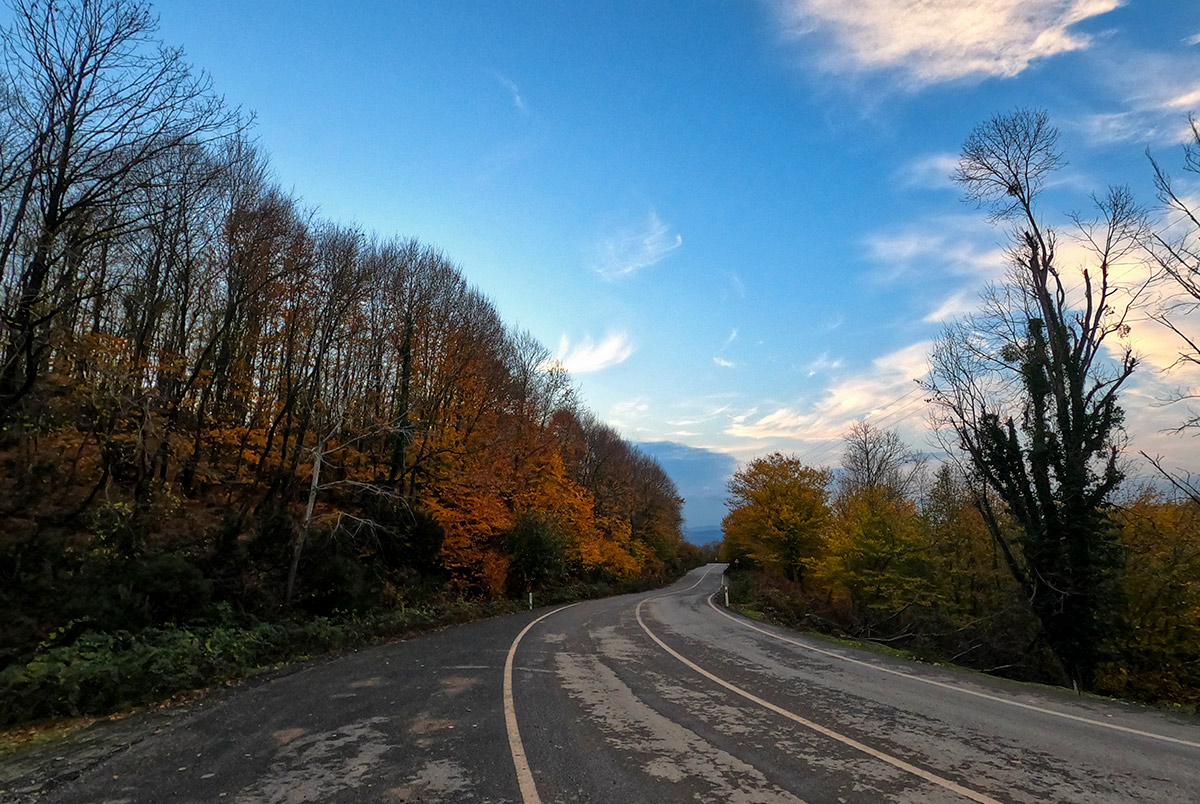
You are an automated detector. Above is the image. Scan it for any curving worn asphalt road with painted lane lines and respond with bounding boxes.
[7,565,1200,804]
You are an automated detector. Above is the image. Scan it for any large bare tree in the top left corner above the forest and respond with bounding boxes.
[0,0,238,419]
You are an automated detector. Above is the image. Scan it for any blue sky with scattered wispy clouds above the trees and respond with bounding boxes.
[156,0,1200,526]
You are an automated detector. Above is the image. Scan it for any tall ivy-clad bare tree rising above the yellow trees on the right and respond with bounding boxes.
[926,110,1145,686]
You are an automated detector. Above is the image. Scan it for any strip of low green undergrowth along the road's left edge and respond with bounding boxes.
[0,578,673,757]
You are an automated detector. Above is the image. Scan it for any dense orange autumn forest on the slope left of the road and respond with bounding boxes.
[0,0,696,720]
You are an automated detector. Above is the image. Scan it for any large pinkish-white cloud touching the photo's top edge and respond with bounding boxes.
[779,0,1122,86]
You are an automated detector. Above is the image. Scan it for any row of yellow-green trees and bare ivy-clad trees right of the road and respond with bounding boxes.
[724,109,1200,707]
